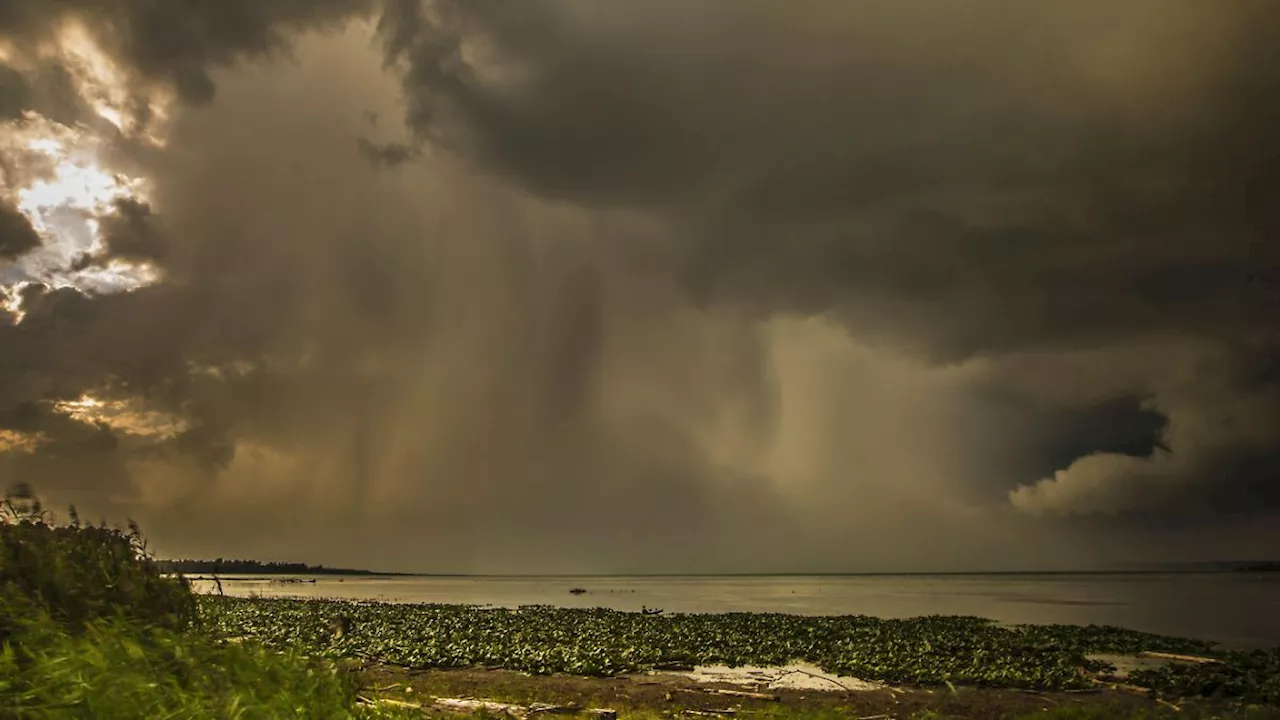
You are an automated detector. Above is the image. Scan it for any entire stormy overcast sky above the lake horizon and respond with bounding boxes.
[0,0,1280,573]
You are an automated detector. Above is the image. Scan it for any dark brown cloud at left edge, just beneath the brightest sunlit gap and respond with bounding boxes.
[0,271,270,507]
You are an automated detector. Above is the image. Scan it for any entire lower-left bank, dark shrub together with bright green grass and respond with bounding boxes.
[0,493,403,720]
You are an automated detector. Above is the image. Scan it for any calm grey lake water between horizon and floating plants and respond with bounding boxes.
[196,573,1280,647]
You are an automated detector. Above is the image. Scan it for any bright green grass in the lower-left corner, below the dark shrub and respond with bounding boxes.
[0,618,384,719]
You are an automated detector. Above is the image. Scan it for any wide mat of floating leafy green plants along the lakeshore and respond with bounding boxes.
[201,597,1275,700]
